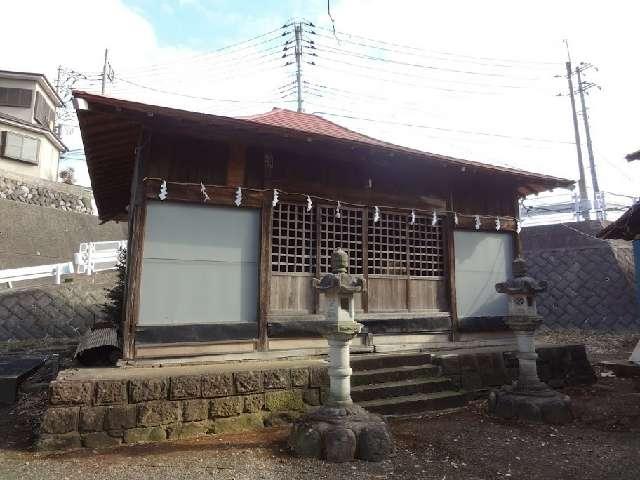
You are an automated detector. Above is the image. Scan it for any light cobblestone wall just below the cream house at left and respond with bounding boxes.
[0,170,93,214]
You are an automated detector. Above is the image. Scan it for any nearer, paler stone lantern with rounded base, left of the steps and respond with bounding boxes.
[289,249,393,462]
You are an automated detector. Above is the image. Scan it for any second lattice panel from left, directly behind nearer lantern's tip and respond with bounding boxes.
[318,206,363,274]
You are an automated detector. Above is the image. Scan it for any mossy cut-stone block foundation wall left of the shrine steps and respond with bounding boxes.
[38,367,328,450]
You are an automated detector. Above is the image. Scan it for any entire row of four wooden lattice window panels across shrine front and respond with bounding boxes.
[271,202,444,277]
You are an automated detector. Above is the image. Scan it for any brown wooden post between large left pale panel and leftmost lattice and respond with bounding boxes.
[258,196,273,351]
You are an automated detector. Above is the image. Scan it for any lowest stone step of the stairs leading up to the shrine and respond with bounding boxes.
[358,390,467,415]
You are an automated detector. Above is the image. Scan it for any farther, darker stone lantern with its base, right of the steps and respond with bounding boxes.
[489,257,573,423]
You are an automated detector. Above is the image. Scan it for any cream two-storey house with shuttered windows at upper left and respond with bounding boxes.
[0,70,66,181]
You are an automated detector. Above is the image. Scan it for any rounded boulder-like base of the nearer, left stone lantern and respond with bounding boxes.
[289,405,393,463]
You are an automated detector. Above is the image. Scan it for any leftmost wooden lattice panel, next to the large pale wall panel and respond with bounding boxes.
[271,202,316,273]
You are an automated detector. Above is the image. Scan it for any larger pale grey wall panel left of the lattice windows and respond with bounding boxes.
[139,202,260,326]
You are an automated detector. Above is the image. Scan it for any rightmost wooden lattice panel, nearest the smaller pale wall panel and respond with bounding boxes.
[408,216,444,277]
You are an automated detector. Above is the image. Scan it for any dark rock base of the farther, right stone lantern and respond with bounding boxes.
[489,384,573,425]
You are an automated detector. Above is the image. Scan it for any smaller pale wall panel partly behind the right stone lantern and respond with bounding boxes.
[453,231,513,318]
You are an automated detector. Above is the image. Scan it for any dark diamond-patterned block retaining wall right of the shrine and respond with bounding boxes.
[521,221,640,331]
